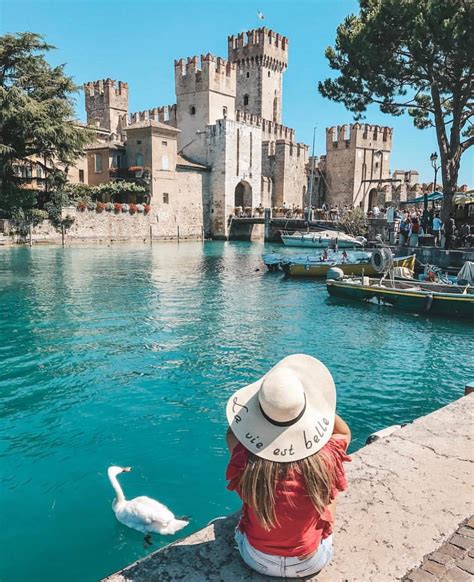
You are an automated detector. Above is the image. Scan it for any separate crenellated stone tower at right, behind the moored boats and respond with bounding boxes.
[324,123,393,210]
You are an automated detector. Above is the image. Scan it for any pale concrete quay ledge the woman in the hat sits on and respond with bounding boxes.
[106,394,474,582]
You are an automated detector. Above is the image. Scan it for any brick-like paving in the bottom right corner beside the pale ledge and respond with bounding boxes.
[402,516,474,582]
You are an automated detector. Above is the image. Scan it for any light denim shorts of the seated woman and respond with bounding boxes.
[235,529,332,578]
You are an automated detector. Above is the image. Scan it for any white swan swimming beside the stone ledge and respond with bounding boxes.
[107,466,189,535]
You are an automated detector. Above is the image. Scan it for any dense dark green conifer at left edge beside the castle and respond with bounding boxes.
[0,32,92,221]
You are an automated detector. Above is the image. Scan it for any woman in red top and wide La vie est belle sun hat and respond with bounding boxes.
[226,354,351,578]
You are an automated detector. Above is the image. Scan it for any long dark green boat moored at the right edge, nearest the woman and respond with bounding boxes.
[326,277,474,319]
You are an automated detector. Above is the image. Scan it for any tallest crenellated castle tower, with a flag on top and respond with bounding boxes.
[227,28,288,123]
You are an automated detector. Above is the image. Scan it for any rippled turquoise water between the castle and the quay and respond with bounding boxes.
[0,243,474,582]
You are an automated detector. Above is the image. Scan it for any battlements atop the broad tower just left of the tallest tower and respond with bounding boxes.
[174,53,236,95]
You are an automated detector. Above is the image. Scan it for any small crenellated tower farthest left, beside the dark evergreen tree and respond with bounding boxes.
[84,79,128,135]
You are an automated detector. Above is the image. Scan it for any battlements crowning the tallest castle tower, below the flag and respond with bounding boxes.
[227,28,288,70]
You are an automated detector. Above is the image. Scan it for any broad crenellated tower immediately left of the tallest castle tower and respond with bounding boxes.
[174,53,236,159]
